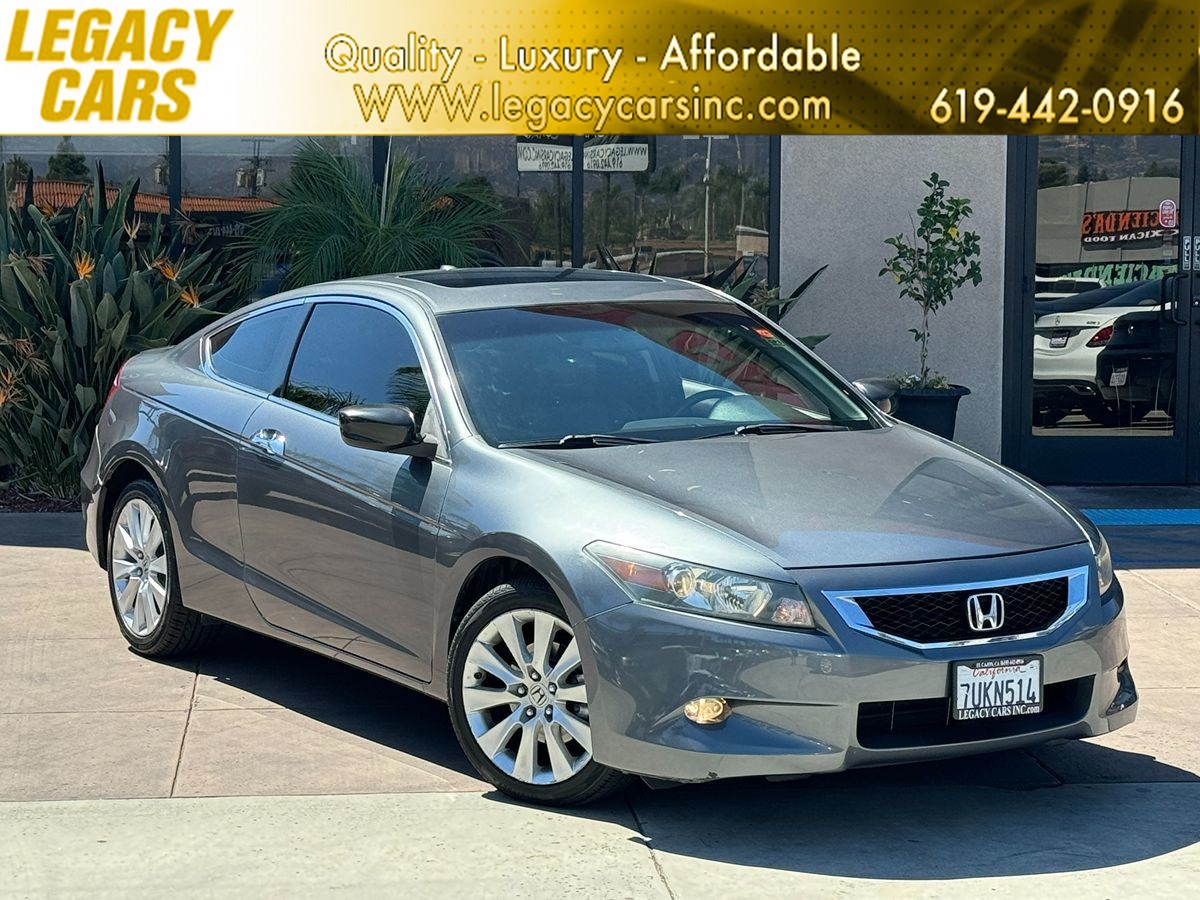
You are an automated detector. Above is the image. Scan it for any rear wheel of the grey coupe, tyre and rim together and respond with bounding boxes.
[108,481,220,656]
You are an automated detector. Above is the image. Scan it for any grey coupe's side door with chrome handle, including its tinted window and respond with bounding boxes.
[238,300,450,680]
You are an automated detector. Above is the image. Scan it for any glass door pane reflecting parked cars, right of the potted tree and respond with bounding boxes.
[1018,136,1200,484]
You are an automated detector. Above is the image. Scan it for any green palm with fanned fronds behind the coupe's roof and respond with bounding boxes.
[236,140,511,289]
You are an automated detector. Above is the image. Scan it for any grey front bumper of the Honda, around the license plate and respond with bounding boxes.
[587,548,1136,781]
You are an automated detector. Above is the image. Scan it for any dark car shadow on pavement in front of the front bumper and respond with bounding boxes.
[631,744,1200,880]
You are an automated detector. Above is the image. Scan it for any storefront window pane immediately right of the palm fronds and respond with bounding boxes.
[390,136,571,266]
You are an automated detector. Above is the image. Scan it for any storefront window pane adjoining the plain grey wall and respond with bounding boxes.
[583,134,770,277]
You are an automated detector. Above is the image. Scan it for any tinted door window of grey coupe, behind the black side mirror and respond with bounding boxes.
[283,304,430,422]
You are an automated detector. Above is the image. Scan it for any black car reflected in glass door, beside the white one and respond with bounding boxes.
[1096,308,1177,424]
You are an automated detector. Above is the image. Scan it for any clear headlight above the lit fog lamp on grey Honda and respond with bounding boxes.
[587,541,815,628]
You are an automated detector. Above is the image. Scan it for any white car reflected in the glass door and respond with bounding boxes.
[1033,281,1159,426]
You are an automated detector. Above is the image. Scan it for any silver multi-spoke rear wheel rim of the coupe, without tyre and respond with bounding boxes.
[108,497,169,637]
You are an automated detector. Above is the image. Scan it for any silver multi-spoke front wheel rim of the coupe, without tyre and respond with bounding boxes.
[460,610,592,785]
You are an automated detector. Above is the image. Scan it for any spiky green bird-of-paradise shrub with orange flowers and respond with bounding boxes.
[0,168,232,498]
